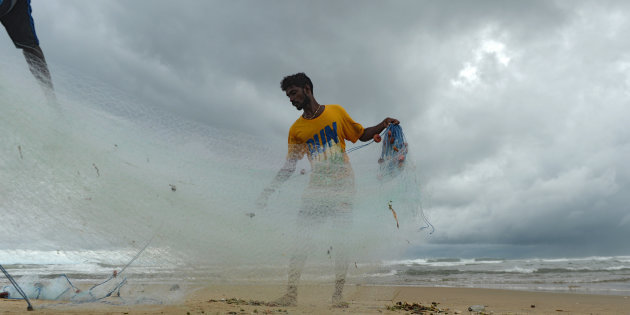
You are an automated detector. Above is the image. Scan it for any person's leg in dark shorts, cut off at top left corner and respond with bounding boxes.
[0,0,55,101]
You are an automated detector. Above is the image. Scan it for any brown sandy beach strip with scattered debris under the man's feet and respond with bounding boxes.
[0,284,630,314]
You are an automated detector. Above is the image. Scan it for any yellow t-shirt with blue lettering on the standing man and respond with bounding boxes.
[287,105,363,183]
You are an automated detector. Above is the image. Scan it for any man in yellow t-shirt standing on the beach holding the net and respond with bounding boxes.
[258,73,399,306]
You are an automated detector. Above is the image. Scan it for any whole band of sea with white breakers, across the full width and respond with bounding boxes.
[0,249,630,296]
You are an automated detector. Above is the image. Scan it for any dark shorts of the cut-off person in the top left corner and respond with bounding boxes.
[0,0,39,48]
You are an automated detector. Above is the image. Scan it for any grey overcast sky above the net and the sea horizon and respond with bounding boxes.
[0,0,630,255]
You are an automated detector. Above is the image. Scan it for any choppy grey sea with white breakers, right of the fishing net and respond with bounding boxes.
[366,256,630,295]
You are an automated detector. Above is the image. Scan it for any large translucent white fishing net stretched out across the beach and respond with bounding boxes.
[0,56,432,312]
